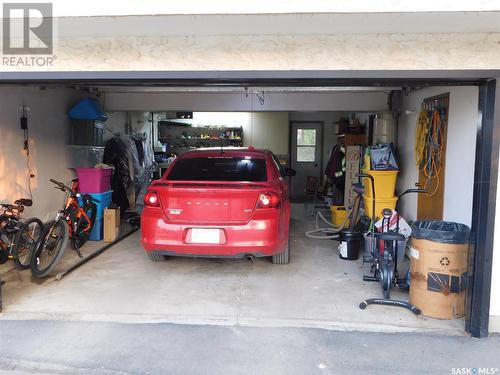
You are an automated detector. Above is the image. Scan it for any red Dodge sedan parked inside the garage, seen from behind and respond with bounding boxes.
[141,147,295,264]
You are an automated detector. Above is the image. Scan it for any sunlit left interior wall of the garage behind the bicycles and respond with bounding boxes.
[0,86,82,221]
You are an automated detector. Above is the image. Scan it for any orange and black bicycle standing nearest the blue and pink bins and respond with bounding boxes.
[31,179,99,277]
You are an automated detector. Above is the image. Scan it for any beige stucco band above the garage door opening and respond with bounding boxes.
[0,33,500,71]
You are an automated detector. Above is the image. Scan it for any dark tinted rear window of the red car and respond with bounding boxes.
[167,156,267,181]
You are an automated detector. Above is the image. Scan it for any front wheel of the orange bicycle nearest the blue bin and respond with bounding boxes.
[31,220,69,277]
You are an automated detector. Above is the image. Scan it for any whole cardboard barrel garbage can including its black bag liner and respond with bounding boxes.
[410,221,470,319]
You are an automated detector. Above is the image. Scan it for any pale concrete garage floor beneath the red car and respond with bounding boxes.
[0,205,464,335]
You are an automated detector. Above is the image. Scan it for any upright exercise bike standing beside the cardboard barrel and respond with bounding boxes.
[358,173,428,315]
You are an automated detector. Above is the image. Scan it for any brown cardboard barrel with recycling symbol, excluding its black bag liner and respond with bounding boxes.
[410,238,468,319]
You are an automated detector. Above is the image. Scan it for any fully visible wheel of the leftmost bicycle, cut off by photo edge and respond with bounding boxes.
[12,218,43,270]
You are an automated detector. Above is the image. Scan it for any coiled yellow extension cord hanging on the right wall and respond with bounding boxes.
[415,107,444,197]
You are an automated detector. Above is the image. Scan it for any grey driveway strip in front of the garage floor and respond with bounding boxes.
[0,320,500,375]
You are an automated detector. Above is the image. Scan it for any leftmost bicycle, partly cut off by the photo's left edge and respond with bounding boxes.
[0,198,43,270]
